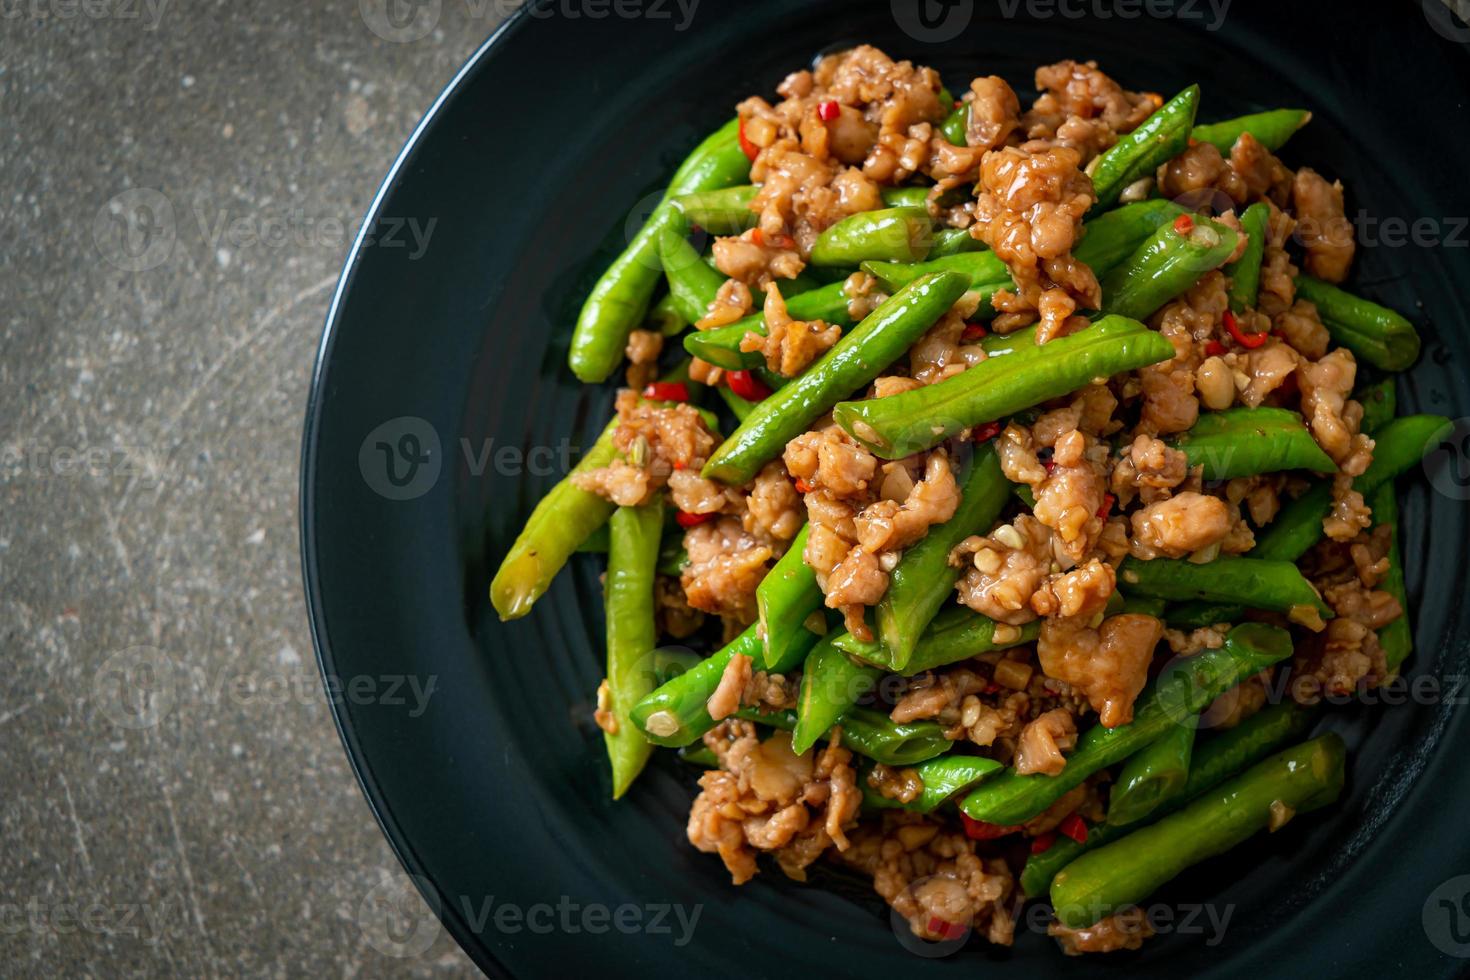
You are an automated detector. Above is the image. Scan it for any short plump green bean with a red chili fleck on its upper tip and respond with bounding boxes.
[1103,215,1236,320]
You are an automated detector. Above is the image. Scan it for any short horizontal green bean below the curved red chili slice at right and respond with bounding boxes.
[1173,407,1338,480]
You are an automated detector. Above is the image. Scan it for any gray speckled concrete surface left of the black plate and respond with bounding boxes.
[0,0,506,977]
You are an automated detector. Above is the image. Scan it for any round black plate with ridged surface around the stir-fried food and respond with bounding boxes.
[301,0,1470,977]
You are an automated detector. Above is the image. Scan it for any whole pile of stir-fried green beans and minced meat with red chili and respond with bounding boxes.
[491,46,1448,954]
